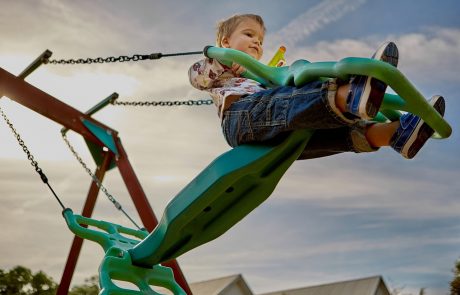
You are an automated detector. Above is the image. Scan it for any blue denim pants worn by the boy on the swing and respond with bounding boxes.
[222,79,377,160]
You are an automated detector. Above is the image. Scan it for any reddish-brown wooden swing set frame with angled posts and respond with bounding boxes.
[0,50,192,295]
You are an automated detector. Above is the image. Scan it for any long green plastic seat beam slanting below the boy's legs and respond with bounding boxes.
[129,130,313,266]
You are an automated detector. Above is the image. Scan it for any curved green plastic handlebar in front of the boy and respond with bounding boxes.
[204,46,452,138]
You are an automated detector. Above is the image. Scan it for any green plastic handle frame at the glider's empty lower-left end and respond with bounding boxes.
[62,209,186,295]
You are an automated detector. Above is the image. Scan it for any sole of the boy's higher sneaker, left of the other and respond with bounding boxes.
[358,42,399,120]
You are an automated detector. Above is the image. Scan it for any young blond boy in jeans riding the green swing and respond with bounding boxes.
[189,14,445,159]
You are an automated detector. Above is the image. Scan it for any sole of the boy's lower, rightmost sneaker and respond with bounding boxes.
[401,95,446,159]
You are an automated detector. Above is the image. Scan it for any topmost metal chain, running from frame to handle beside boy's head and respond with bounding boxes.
[48,51,203,65]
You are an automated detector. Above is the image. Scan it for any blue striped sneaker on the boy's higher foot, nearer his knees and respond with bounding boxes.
[345,42,399,120]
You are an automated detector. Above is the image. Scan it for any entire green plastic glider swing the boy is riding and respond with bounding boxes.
[64,47,452,295]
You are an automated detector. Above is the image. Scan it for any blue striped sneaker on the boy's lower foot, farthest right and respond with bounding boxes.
[390,95,446,159]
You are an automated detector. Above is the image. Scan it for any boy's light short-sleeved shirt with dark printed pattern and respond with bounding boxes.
[188,58,265,119]
